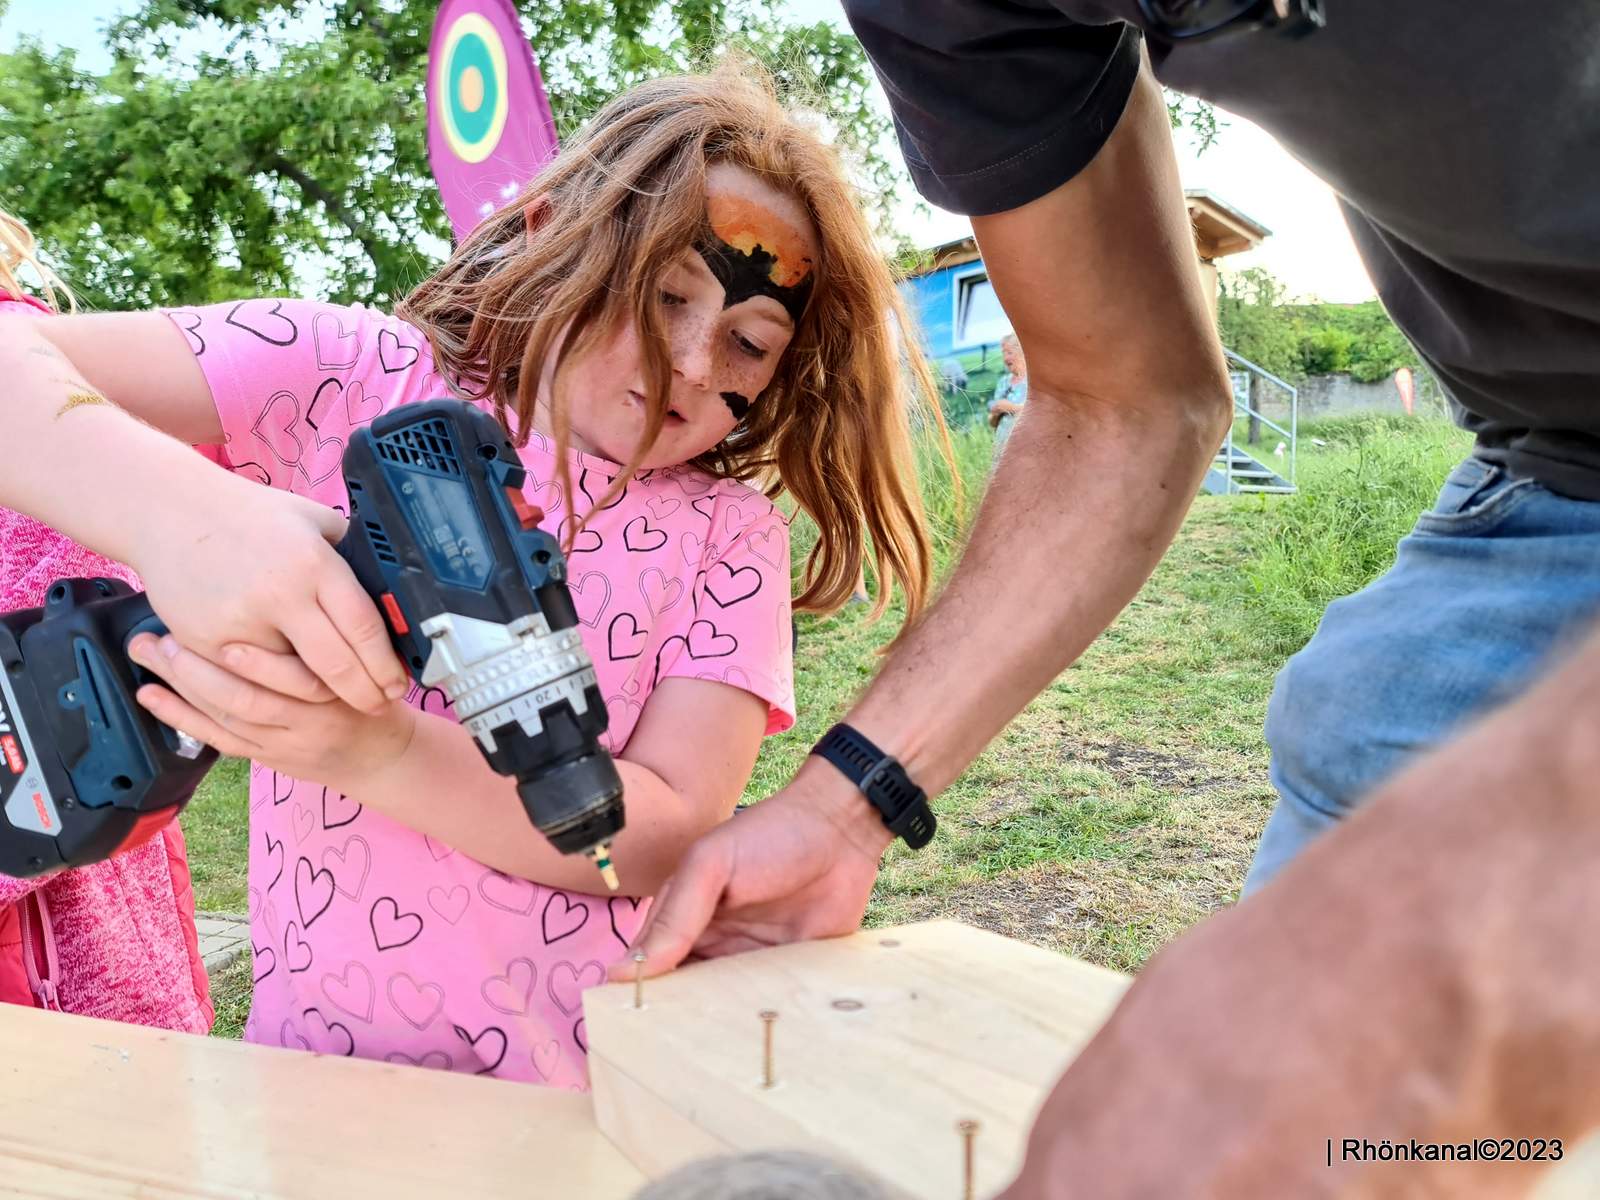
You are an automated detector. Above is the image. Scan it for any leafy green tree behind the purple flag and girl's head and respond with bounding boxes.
[0,0,896,307]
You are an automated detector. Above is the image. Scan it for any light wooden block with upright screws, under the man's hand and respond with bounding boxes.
[584,922,1126,1200]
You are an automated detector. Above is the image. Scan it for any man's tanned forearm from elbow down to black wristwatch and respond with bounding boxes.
[850,382,1221,792]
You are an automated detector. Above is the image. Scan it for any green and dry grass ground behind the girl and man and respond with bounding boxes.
[184,416,1469,1035]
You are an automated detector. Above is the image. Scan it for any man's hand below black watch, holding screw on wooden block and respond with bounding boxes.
[611,758,893,979]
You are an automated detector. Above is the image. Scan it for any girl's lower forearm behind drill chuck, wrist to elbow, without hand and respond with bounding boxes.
[348,715,726,896]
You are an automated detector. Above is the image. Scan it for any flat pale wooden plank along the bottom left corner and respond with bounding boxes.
[0,1005,643,1200]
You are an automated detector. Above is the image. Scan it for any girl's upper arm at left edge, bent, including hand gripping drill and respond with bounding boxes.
[0,314,405,720]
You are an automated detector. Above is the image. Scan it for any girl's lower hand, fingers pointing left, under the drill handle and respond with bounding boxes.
[128,634,416,792]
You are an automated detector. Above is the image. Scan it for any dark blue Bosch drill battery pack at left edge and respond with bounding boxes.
[0,579,218,877]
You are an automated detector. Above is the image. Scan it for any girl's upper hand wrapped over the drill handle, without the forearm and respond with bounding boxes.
[131,472,408,713]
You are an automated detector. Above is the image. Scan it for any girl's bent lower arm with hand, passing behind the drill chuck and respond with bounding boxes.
[131,637,768,896]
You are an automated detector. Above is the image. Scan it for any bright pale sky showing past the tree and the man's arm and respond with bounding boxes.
[0,0,1374,302]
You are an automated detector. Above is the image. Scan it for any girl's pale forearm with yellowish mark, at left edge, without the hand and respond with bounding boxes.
[0,317,229,562]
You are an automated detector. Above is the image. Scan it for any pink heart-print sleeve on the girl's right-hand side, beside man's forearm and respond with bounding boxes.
[662,496,795,734]
